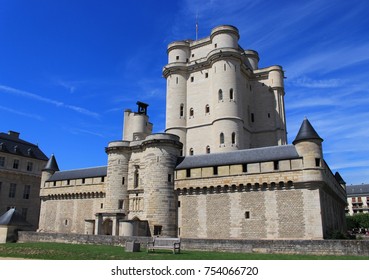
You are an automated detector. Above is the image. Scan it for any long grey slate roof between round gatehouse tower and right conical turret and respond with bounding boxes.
[176,145,300,170]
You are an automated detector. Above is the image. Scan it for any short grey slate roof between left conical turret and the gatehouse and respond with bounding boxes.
[47,166,107,182]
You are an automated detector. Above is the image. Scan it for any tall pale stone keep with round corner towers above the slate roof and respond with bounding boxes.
[163,25,287,155]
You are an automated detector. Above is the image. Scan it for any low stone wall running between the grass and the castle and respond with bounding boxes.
[18,231,369,256]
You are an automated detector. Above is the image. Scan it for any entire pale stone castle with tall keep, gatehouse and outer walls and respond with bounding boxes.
[38,26,346,239]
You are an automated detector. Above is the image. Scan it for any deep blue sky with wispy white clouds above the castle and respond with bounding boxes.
[0,0,369,184]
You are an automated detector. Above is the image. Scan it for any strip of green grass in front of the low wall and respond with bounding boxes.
[0,243,369,260]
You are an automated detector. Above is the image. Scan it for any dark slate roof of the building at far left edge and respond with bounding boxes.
[0,132,48,161]
